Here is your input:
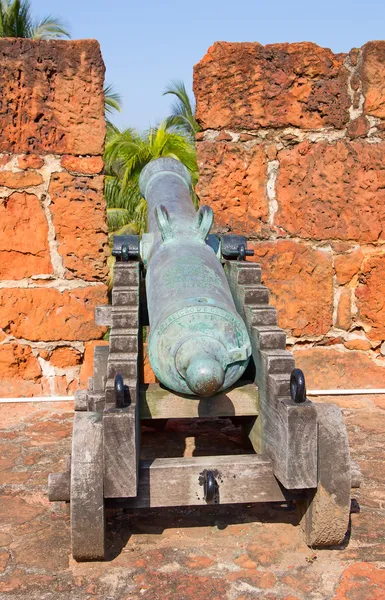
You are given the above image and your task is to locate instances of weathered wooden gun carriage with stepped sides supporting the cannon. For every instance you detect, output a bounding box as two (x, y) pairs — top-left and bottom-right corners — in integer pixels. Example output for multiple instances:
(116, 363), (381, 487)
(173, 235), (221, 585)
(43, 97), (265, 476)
(49, 159), (360, 561)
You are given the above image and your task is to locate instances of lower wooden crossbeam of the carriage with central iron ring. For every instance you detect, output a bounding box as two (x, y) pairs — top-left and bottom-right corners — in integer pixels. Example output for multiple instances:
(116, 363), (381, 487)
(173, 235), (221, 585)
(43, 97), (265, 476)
(124, 454), (292, 507)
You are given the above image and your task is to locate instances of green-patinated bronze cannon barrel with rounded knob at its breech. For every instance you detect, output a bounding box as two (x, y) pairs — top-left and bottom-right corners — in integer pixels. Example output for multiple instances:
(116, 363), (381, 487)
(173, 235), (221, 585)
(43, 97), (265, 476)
(139, 158), (251, 396)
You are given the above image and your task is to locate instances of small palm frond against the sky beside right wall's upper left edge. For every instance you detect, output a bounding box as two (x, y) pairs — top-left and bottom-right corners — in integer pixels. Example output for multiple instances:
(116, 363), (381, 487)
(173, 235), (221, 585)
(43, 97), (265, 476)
(163, 81), (200, 140)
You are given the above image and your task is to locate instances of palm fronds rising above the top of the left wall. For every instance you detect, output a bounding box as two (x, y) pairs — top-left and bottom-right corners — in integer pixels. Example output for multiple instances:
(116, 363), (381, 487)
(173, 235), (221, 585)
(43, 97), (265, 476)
(0, 0), (70, 40)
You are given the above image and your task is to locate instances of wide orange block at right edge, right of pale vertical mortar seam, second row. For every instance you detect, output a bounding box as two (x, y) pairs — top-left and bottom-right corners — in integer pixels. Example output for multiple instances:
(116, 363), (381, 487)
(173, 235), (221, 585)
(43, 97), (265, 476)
(275, 140), (385, 242)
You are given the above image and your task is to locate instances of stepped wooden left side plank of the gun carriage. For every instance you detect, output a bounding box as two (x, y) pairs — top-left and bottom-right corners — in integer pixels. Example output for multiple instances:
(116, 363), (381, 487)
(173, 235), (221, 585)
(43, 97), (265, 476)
(103, 261), (140, 498)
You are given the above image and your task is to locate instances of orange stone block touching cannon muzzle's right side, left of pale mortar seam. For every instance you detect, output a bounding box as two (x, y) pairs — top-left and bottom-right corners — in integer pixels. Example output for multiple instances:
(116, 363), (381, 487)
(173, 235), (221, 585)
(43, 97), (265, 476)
(197, 142), (268, 235)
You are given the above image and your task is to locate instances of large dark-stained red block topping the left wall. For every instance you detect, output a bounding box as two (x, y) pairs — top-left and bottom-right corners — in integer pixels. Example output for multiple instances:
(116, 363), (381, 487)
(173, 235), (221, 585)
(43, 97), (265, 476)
(0, 38), (106, 155)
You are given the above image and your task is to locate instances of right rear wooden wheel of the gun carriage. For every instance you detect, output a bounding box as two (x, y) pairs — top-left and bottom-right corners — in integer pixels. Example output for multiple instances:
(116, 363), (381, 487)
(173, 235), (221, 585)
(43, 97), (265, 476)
(297, 404), (352, 547)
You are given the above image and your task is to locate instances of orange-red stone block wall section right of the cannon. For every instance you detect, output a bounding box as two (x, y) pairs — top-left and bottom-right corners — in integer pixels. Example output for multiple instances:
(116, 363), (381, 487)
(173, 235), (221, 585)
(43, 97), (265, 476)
(194, 42), (385, 388)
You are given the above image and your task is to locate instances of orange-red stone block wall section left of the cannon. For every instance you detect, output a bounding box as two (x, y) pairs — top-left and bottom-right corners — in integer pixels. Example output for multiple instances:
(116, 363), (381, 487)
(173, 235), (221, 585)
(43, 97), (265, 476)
(0, 39), (108, 397)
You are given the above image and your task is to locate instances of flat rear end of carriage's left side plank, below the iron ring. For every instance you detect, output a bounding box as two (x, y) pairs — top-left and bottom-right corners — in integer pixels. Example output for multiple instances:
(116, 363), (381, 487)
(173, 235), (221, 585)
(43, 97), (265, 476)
(103, 404), (140, 498)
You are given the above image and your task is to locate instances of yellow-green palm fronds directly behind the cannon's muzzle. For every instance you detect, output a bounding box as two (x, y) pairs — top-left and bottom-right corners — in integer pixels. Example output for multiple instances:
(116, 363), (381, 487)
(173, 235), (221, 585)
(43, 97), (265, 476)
(104, 121), (198, 234)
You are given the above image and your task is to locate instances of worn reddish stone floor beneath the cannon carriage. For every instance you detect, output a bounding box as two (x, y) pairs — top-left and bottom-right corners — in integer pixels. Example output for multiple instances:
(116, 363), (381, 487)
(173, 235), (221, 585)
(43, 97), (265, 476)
(0, 396), (385, 600)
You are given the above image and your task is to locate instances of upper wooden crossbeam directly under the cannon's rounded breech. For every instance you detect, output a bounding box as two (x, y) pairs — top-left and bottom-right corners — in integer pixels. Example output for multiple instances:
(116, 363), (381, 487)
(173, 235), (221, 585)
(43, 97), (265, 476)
(139, 382), (258, 419)
